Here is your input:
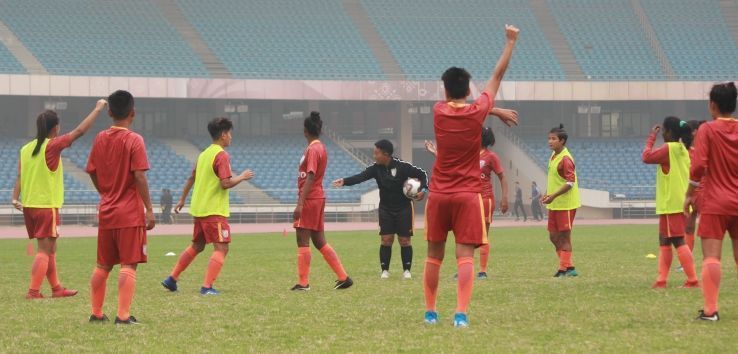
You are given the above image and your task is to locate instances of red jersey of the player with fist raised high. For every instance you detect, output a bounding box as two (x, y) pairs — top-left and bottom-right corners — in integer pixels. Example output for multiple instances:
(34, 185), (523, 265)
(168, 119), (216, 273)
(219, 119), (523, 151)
(430, 92), (493, 193)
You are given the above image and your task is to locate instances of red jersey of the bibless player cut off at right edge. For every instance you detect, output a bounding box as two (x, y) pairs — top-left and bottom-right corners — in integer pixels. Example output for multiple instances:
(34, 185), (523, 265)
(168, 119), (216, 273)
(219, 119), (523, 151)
(689, 118), (738, 216)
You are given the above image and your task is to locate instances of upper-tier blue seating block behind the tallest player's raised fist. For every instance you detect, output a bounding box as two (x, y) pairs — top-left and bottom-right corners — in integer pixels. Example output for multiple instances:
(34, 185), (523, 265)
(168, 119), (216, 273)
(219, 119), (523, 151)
(362, 0), (565, 80)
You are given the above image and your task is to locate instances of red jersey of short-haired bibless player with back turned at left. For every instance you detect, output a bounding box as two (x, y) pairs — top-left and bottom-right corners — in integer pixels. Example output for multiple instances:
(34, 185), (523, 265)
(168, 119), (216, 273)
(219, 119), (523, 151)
(86, 127), (149, 230)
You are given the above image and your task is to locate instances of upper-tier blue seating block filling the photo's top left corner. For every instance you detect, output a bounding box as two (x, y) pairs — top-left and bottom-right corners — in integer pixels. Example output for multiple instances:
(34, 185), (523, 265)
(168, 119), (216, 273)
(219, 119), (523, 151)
(0, 0), (207, 77)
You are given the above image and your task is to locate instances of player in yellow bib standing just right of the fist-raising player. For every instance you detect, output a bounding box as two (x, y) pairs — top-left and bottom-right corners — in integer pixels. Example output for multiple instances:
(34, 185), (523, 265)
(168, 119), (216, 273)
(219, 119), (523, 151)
(541, 124), (582, 277)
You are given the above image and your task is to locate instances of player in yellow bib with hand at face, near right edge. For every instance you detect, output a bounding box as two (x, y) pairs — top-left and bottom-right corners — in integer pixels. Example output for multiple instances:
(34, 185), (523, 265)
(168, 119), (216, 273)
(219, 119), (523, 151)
(642, 117), (699, 289)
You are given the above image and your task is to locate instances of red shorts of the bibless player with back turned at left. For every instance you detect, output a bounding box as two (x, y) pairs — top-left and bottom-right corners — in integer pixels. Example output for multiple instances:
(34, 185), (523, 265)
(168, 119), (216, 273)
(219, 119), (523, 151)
(97, 226), (147, 266)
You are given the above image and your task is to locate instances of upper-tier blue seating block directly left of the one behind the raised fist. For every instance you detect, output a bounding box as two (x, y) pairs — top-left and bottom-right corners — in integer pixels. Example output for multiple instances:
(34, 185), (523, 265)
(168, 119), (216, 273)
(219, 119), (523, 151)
(177, 0), (385, 80)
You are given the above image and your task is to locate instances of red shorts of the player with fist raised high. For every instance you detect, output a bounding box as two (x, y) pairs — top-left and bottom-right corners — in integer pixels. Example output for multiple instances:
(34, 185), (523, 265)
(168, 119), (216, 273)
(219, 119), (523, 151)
(425, 192), (489, 246)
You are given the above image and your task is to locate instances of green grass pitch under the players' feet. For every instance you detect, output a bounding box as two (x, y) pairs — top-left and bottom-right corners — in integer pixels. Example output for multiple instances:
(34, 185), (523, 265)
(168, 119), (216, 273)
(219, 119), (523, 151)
(0, 226), (738, 353)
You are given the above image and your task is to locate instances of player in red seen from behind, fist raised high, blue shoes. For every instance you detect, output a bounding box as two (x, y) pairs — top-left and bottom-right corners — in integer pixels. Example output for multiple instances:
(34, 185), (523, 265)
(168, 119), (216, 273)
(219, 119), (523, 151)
(423, 25), (519, 327)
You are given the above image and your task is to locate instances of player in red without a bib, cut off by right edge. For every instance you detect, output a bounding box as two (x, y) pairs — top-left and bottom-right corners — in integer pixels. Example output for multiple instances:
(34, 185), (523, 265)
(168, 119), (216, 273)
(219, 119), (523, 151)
(684, 82), (738, 321)
